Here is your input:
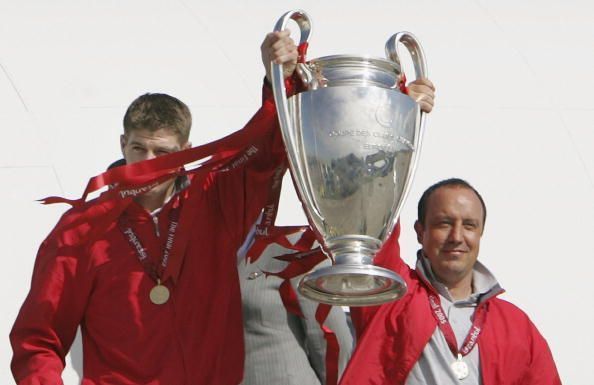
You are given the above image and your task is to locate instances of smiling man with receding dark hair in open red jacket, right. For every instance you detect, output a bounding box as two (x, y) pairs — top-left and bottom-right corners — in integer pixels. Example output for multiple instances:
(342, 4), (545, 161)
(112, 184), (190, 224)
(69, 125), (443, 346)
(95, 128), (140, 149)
(341, 179), (561, 385)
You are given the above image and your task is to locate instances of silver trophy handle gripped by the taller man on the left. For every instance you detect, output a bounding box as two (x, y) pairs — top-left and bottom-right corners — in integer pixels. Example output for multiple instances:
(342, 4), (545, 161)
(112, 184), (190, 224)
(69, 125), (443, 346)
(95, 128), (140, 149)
(270, 10), (322, 220)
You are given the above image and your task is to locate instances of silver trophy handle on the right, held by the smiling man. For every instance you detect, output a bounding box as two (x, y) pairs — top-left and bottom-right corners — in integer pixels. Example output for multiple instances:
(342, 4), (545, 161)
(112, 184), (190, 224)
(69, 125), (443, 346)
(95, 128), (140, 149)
(386, 31), (428, 239)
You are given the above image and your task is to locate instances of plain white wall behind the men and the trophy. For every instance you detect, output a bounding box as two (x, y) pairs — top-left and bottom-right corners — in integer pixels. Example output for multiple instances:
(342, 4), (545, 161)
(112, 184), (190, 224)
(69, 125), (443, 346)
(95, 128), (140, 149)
(0, 0), (594, 385)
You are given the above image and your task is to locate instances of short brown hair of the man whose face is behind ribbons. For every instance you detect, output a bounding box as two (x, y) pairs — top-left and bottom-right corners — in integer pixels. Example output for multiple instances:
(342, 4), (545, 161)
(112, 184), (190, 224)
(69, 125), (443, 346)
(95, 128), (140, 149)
(124, 94), (192, 144)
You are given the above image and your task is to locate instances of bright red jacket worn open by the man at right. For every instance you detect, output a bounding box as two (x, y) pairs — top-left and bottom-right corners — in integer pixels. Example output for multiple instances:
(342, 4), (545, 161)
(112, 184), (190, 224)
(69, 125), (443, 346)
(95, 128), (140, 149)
(340, 228), (561, 385)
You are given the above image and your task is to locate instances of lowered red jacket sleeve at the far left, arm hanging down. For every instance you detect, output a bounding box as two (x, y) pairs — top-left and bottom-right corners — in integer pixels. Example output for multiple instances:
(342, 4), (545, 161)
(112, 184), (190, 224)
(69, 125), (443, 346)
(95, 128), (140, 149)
(10, 225), (90, 385)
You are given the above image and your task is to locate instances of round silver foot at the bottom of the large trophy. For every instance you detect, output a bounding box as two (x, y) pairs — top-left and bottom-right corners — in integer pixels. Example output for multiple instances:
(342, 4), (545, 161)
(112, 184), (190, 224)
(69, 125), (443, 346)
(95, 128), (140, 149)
(299, 265), (406, 306)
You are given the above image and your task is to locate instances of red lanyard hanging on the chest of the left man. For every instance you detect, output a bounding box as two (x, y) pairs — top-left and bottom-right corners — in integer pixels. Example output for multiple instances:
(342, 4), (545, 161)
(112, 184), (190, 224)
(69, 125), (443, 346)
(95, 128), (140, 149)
(118, 197), (181, 282)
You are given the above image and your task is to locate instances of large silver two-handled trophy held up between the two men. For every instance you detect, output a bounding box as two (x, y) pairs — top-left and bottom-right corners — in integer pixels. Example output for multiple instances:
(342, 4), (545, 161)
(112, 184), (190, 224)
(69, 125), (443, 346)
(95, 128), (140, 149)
(272, 11), (427, 306)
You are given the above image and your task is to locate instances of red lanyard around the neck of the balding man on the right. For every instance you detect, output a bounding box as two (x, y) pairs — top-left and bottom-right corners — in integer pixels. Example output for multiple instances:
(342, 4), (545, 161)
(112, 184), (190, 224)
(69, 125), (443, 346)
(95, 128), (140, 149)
(429, 293), (486, 356)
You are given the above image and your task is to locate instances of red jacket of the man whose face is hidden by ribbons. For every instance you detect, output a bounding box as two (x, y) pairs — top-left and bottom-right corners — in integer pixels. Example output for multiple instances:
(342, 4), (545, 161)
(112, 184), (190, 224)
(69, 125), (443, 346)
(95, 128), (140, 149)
(10, 88), (284, 385)
